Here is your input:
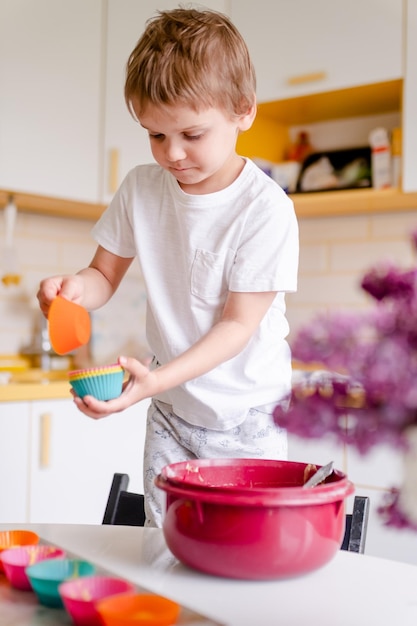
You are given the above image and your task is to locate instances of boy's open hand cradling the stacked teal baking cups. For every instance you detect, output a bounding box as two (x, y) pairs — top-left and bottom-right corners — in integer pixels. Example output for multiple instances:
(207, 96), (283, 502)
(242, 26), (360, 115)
(71, 357), (156, 419)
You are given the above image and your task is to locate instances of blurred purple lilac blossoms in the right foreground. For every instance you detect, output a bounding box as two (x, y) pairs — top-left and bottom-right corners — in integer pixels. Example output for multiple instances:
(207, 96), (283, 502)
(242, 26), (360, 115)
(274, 231), (417, 530)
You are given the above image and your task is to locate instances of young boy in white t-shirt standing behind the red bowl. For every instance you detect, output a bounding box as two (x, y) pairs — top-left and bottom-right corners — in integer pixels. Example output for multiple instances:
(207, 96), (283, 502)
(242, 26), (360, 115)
(38, 9), (298, 526)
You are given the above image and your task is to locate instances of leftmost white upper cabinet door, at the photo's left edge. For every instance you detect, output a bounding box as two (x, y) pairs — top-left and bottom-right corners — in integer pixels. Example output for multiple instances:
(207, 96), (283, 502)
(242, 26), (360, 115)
(0, 0), (103, 202)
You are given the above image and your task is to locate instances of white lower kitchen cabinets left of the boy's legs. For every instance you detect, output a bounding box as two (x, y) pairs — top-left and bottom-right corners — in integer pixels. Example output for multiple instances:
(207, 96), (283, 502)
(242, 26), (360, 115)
(0, 399), (149, 524)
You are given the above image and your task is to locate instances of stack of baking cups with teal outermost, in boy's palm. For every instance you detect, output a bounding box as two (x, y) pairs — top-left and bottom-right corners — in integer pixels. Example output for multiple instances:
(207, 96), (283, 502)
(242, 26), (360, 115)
(69, 364), (124, 401)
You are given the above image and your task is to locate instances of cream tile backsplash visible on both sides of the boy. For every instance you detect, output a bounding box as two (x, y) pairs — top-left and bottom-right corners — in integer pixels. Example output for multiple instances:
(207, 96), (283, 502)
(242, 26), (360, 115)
(0, 207), (417, 362)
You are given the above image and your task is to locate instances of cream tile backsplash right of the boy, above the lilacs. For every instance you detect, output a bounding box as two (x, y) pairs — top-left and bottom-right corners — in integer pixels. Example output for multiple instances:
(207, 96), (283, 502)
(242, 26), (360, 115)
(287, 207), (417, 342)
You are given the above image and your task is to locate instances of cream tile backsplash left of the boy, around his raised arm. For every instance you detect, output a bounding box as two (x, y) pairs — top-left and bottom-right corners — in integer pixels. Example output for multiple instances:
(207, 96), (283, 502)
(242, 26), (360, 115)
(0, 212), (147, 363)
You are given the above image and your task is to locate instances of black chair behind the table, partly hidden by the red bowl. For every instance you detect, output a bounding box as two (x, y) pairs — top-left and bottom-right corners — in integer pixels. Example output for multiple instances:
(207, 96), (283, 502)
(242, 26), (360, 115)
(103, 474), (369, 553)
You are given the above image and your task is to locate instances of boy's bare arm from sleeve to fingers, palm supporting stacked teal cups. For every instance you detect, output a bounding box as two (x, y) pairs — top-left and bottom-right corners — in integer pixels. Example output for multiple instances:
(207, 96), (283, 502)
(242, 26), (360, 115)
(75, 292), (276, 418)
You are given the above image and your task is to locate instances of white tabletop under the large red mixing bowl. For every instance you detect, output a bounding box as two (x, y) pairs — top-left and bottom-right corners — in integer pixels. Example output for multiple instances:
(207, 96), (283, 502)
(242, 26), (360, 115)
(0, 524), (417, 626)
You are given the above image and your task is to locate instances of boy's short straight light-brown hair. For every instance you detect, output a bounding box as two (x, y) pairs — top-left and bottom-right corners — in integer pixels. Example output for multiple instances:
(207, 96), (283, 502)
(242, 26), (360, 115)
(125, 8), (256, 117)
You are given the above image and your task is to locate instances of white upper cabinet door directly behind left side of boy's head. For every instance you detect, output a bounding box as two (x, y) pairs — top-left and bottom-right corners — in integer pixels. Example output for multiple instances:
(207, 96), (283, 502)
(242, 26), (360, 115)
(102, 0), (226, 202)
